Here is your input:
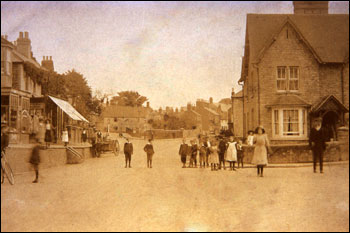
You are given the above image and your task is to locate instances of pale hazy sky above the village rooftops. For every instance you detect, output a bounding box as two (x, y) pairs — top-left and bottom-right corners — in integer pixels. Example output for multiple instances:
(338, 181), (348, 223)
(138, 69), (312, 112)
(1, 1), (349, 108)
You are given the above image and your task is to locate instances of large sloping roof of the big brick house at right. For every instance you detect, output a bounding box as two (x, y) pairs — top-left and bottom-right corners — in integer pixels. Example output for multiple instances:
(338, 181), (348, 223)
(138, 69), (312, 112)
(245, 14), (349, 63)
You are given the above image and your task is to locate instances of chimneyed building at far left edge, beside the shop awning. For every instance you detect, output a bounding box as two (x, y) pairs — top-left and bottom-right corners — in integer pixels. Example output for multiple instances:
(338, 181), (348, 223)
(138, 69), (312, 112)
(1, 32), (42, 143)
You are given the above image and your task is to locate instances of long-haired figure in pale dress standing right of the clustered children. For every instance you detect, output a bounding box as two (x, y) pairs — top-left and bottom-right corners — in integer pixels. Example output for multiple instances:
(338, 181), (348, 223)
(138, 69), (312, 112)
(252, 126), (270, 177)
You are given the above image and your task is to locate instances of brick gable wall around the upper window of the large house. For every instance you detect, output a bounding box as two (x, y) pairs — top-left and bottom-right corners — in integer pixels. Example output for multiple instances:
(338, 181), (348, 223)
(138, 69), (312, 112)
(254, 24), (324, 141)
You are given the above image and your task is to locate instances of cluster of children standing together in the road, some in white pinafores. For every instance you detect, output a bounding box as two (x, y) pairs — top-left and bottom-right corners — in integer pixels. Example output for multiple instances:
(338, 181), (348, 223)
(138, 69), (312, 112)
(179, 137), (244, 171)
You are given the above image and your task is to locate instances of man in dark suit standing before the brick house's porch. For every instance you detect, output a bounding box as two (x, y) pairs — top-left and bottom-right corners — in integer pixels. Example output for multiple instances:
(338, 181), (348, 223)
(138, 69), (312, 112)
(309, 119), (326, 173)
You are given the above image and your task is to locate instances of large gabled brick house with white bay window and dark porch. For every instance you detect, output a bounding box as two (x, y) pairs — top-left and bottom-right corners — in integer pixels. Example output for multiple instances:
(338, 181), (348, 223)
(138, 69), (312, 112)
(239, 2), (349, 143)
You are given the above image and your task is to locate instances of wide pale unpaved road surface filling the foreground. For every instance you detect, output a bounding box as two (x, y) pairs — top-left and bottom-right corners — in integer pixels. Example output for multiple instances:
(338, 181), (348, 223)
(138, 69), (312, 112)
(1, 140), (349, 232)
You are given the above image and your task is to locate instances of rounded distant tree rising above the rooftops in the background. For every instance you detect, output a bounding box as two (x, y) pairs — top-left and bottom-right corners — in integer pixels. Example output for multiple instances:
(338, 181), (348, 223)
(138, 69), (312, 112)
(111, 91), (148, 107)
